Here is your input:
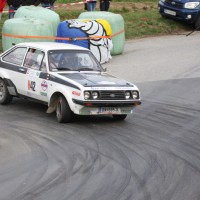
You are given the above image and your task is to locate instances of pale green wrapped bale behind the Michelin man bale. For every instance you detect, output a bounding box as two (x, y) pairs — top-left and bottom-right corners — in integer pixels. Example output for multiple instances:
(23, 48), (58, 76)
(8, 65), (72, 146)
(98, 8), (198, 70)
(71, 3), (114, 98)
(78, 11), (125, 55)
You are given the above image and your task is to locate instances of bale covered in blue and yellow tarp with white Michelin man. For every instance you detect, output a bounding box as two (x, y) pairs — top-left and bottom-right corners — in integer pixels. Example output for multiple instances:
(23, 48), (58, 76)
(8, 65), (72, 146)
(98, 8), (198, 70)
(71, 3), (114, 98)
(57, 19), (113, 63)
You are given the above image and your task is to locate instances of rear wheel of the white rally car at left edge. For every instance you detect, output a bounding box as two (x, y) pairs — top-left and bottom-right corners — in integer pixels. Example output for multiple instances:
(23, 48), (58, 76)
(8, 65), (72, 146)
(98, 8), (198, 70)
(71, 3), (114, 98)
(0, 79), (13, 105)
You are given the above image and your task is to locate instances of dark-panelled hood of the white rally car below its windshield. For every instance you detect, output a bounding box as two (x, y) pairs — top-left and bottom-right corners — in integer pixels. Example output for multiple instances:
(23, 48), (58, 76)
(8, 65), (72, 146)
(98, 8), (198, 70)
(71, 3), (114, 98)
(59, 72), (133, 87)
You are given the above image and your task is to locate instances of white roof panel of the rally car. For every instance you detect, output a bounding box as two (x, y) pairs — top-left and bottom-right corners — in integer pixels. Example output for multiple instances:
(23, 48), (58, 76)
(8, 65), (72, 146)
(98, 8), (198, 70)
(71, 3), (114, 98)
(16, 42), (88, 51)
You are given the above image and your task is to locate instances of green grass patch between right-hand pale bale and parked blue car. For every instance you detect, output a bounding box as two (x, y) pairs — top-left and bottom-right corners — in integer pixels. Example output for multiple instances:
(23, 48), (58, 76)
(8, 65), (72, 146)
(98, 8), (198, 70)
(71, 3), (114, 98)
(119, 9), (191, 39)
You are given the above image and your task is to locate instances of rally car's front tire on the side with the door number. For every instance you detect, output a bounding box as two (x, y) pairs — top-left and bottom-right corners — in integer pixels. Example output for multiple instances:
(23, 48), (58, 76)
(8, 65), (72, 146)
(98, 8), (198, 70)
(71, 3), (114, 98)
(56, 96), (73, 123)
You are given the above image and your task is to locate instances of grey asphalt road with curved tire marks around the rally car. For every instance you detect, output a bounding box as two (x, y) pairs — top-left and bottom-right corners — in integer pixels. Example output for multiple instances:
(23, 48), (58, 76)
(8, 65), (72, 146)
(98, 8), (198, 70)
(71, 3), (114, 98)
(0, 33), (200, 200)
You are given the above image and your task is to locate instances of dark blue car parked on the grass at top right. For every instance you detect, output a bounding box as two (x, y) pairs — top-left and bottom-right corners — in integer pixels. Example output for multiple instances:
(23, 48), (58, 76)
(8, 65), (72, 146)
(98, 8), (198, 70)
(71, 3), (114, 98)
(158, 0), (200, 29)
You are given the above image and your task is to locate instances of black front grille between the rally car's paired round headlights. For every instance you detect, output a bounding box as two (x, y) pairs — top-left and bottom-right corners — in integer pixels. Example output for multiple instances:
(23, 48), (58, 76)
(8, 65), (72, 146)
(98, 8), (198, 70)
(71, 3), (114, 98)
(100, 90), (125, 100)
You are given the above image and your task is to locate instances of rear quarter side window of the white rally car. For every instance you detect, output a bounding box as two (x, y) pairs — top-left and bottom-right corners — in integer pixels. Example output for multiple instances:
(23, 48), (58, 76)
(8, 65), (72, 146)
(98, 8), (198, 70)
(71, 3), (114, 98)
(3, 47), (26, 65)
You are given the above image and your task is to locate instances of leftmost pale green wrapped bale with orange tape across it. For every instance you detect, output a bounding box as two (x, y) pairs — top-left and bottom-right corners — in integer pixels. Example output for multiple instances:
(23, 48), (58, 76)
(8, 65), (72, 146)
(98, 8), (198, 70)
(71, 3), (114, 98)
(2, 18), (54, 51)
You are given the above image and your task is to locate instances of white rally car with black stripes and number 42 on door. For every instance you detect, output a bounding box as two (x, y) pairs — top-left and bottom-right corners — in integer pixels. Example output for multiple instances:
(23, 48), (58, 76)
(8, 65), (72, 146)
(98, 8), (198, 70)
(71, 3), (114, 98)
(0, 42), (141, 122)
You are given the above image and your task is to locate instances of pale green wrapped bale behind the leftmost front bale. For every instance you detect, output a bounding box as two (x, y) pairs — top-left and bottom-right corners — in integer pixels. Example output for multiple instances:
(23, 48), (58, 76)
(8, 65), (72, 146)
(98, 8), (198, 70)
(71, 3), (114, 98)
(14, 6), (60, 36)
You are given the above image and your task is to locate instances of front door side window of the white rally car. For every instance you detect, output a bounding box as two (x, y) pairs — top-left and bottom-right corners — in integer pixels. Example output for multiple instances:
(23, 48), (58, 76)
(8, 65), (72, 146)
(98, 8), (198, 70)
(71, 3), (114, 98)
(24, 48), (44, 70)
